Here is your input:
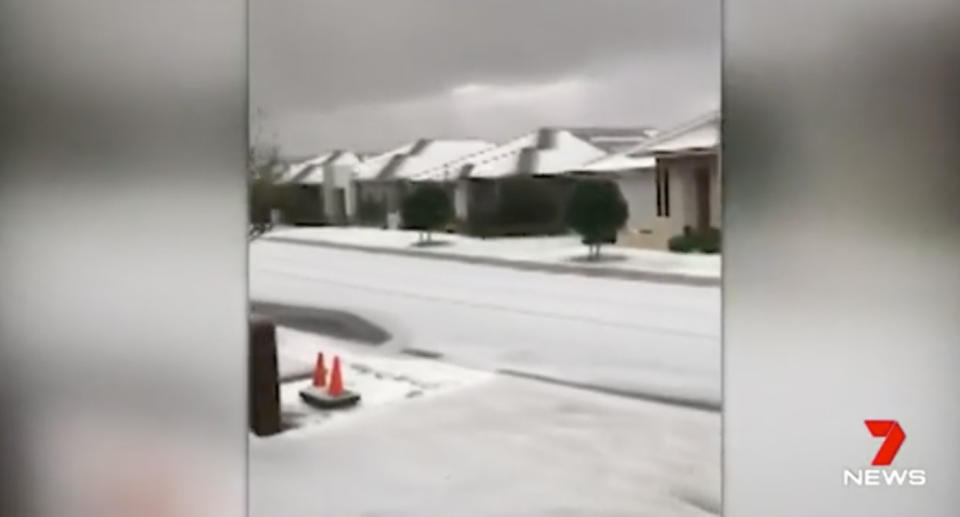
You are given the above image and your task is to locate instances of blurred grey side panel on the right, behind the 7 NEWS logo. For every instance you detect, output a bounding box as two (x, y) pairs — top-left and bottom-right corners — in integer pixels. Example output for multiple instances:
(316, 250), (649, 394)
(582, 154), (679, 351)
(723, 0), (960, 517)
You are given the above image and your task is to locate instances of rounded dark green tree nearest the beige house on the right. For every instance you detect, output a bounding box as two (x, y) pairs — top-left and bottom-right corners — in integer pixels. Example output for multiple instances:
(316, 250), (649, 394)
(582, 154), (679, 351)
(567, 179), (629, 260)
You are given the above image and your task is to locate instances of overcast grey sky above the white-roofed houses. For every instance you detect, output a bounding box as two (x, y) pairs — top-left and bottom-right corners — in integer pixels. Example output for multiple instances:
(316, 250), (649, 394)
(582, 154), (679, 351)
(250, 0), (721, 155)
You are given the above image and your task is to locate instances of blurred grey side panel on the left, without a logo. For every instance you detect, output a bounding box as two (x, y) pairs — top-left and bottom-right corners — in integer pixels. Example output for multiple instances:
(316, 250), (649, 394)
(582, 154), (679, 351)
(0, 0), (248, 515)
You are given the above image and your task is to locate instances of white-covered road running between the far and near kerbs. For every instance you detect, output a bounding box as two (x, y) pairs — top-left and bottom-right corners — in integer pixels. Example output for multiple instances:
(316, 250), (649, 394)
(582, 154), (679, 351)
(250, 241), (720, 405)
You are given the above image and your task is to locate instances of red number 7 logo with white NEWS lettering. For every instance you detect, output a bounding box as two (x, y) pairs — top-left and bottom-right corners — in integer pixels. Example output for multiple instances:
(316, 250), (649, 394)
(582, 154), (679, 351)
(843, 420), (927, 486)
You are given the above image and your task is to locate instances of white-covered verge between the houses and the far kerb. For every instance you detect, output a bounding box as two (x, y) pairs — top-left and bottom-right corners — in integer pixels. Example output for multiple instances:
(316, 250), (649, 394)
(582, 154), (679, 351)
(266, 227), (720, 278)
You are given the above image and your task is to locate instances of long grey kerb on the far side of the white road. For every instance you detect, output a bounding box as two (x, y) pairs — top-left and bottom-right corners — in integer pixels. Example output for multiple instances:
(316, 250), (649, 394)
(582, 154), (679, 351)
(260, 236), (720, 287)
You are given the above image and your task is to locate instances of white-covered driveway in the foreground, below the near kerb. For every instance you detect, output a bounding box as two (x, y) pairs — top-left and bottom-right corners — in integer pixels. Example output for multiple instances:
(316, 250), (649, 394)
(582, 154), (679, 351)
(249, 377), (720, 517)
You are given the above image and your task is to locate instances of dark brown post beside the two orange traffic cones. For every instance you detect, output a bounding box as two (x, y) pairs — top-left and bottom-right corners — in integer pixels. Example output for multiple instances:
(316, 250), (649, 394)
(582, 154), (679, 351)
(248, 315), (281, 436)
